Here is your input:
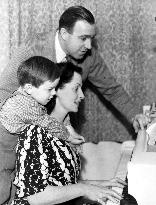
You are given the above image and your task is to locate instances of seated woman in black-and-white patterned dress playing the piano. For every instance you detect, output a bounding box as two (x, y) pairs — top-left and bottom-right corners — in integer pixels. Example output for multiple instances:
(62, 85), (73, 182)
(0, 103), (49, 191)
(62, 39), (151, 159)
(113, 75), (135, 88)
(11, 63), (124, 205)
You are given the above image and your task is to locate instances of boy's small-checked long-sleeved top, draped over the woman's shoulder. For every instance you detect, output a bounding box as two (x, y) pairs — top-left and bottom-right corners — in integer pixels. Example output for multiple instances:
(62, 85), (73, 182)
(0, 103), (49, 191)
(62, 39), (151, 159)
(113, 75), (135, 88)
(0, 88), (69, 140)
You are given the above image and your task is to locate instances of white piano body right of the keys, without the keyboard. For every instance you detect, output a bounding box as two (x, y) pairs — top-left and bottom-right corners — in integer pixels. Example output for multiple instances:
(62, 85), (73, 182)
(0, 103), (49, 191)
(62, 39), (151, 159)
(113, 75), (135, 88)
(127, 123), (156, 205)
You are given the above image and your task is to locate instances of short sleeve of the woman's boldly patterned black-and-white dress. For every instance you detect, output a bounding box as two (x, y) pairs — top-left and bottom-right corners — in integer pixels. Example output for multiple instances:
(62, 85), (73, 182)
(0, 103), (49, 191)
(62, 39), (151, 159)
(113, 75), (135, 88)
(14, 125), (48, 197)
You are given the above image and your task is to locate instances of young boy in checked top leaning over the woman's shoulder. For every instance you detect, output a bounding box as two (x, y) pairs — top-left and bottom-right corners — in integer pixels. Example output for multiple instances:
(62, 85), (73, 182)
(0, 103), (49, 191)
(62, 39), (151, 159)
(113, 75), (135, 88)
(0, 56), (84, 144)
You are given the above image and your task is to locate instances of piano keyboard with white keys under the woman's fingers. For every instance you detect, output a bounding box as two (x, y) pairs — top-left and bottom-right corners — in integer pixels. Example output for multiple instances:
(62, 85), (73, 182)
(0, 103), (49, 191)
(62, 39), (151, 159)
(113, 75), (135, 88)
(106, 141), (135, 205)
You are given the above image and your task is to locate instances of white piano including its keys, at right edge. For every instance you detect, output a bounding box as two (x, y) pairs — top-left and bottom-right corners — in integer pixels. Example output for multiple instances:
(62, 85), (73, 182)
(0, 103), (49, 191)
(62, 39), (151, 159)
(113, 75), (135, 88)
(106, 122), (156, 205)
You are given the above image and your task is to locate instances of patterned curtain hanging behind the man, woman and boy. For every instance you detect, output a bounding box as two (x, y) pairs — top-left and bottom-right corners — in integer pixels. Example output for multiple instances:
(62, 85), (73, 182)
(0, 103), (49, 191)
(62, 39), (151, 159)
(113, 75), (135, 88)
(0, 0), (156, 142)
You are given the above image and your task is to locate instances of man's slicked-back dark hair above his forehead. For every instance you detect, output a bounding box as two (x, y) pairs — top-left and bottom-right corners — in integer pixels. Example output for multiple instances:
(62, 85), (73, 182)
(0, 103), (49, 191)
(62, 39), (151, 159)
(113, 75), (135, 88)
(59, 6), (95, 33)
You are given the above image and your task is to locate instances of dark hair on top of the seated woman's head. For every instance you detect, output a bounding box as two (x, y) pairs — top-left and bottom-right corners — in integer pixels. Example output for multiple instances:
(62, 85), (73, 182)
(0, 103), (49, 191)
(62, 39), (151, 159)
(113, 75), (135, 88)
(56, 62), (82, 90)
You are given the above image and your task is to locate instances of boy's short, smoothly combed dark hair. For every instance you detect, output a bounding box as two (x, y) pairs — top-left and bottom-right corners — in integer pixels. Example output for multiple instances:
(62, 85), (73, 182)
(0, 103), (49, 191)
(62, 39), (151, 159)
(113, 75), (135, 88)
(17, 56), (62, 88)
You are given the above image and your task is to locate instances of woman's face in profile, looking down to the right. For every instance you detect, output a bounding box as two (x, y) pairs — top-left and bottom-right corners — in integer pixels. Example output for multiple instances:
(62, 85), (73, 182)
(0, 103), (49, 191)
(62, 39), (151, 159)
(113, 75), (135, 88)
(56, 72), (84, 113)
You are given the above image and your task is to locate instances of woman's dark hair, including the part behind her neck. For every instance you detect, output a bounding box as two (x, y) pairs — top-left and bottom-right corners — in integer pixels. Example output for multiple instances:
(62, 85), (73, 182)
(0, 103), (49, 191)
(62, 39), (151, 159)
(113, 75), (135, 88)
(46, 62), (82, 114)
